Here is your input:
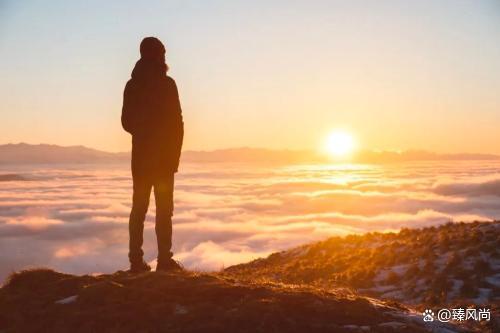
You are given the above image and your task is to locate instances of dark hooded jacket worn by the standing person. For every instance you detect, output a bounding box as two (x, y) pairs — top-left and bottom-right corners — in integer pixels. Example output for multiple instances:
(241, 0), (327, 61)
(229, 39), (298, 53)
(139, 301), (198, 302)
(121, 59), (184, 177)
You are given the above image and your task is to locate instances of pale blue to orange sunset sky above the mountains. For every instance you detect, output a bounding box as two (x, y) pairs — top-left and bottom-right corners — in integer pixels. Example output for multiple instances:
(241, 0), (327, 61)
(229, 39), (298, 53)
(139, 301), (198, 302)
(0, 0), (500, 154)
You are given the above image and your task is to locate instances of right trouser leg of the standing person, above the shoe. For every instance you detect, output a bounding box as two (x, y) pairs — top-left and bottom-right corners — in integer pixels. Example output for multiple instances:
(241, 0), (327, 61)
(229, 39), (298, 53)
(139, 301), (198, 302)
(154, 173), (174, 264)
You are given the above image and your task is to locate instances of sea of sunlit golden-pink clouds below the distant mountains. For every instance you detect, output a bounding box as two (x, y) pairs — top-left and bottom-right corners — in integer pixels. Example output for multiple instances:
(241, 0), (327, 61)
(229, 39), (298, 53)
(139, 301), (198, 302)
(0, 161), (500, 281)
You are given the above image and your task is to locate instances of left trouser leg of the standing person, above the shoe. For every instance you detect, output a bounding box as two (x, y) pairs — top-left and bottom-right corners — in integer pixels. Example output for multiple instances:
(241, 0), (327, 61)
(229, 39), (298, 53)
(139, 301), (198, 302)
(128, 176), (153, 264)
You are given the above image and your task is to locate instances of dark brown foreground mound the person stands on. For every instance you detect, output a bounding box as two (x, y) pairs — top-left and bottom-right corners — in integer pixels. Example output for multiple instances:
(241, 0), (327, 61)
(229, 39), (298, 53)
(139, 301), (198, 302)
(0, 269), (458, 333)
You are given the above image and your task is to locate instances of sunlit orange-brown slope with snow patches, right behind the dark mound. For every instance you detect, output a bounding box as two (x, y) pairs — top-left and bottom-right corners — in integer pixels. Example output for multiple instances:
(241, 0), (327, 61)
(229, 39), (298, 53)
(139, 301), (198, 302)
(223, 221), (500, 332)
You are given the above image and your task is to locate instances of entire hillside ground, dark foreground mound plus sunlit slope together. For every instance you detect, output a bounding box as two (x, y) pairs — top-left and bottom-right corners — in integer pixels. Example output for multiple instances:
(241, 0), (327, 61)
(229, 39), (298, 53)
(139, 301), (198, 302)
(0, 222), (500, 333)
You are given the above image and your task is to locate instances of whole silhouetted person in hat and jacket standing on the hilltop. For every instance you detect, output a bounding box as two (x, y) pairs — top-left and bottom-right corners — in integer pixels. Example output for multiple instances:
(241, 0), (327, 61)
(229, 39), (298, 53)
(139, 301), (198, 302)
(122, 37), (184, 272)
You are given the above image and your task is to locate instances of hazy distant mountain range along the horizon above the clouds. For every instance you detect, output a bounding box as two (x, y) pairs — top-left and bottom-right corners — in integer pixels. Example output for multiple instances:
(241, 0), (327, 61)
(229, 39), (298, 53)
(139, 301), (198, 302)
(0, 143), (500, 164)
